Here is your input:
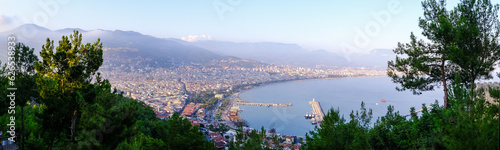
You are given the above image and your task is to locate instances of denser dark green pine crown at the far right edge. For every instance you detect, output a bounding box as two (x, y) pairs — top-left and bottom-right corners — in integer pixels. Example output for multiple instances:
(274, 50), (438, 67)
(450, 0), (500, 91)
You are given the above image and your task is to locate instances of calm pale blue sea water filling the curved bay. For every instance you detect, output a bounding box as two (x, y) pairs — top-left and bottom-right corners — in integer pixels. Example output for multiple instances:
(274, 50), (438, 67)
(240, 77), (498, 136)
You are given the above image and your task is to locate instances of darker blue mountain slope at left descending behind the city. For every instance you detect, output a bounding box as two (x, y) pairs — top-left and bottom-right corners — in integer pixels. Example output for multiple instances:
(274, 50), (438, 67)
(0, 24), (223, 67)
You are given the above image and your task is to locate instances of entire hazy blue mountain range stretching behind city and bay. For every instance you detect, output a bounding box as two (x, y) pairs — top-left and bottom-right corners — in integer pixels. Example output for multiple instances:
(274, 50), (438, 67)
(0, 24), (395, 69)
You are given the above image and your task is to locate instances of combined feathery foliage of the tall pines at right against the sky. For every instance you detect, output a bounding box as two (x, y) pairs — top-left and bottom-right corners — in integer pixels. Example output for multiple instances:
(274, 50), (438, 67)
(387, 0), (500, 108)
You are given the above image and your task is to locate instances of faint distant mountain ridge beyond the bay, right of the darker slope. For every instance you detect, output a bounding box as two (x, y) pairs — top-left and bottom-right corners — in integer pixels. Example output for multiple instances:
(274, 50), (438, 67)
(178, 41), (395, 69)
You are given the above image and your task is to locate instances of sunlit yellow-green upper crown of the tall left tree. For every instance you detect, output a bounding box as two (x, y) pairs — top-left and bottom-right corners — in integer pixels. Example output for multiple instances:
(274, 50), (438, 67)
(35, 30), (103, 96)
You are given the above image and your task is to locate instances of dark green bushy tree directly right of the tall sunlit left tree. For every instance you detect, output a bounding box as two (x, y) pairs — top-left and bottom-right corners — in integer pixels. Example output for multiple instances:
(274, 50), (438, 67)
(71, 76), (141, 149)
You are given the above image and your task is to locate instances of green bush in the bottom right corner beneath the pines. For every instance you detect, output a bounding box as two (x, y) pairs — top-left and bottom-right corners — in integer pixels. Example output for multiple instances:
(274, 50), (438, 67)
(433, 78), (499, 149)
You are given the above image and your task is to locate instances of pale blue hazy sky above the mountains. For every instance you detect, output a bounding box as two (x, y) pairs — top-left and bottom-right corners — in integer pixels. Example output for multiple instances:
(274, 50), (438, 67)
(0, 0), (472, 52)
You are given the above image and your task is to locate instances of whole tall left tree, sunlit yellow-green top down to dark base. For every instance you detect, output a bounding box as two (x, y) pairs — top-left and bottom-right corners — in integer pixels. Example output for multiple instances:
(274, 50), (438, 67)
(35, 31), (103, 148)
